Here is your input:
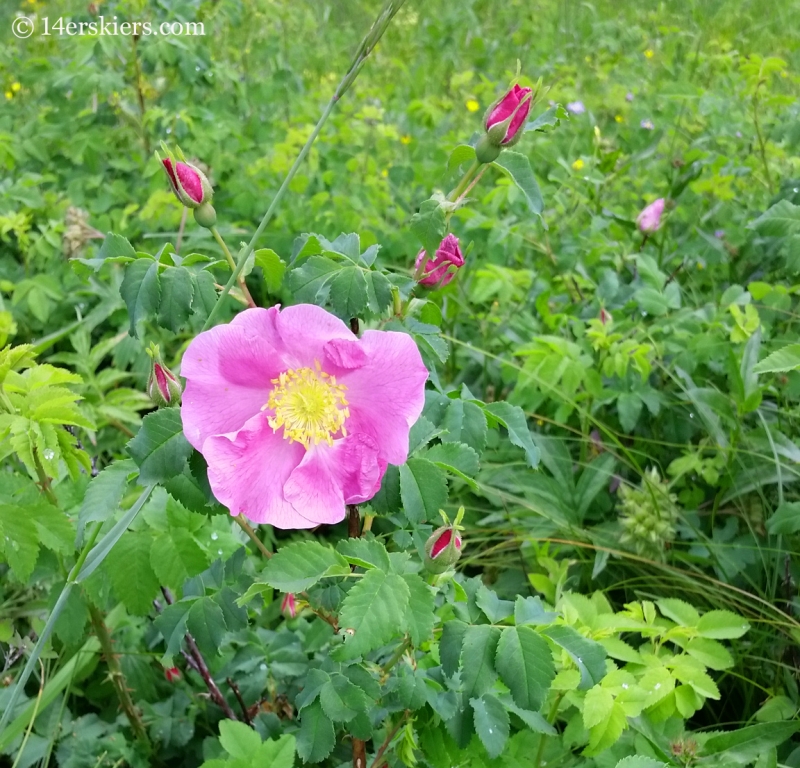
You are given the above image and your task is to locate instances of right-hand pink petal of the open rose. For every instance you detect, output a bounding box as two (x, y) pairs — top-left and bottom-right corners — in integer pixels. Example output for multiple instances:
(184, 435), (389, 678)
(337, 331), (428, 464)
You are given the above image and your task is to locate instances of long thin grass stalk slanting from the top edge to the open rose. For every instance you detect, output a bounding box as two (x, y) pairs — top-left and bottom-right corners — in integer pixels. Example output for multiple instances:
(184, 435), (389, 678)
(203, 0), (405, 331)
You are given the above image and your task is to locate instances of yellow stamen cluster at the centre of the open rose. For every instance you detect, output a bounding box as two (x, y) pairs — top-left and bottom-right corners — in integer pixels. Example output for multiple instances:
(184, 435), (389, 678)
(264, 363), (350, 448)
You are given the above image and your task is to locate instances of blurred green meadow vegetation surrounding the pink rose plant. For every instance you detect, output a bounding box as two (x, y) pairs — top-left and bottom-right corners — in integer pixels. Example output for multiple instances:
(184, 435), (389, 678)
(0, 0), (800, 768)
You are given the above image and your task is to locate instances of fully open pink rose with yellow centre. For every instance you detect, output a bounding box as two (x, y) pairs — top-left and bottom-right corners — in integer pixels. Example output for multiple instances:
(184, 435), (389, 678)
(181, 304), (428, 528)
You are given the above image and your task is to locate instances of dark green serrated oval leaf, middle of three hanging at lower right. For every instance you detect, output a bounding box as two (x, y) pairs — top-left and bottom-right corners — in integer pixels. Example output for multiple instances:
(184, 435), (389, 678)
(495, 626), (556, 712)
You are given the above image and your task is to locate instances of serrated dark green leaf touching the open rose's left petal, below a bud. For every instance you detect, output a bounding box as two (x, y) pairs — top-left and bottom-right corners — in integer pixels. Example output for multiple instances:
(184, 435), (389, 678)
(127, 408), (192, 485)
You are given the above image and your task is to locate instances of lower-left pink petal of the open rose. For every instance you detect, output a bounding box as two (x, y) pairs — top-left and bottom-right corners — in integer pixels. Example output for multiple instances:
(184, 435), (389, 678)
(202, 413), (310, 528)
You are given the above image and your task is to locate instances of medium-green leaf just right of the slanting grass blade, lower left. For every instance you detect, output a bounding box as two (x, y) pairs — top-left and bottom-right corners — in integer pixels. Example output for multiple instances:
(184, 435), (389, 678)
(104, 531), (159, 616)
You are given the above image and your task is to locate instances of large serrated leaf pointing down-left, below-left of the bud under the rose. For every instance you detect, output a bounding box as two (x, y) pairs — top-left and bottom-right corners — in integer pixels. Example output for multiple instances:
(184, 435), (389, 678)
(332, 558), (410, 661)
